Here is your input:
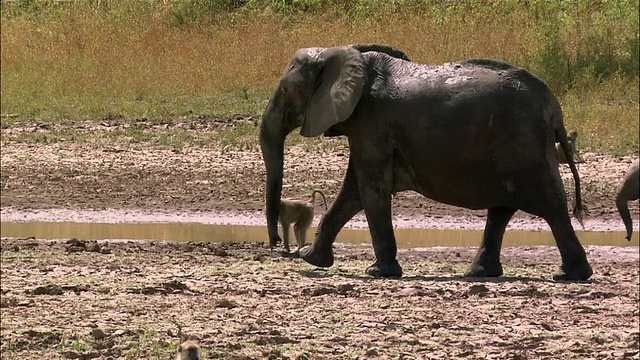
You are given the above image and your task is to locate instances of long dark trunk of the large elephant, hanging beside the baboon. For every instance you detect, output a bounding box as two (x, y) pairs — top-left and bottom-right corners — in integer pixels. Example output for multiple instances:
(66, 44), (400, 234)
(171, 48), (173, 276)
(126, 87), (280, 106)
(260, 98), (287, 246)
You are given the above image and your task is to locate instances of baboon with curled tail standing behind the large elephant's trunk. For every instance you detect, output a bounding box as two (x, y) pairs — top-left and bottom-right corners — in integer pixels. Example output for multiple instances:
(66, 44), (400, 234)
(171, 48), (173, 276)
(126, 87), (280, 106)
(278, 190), (328, 254)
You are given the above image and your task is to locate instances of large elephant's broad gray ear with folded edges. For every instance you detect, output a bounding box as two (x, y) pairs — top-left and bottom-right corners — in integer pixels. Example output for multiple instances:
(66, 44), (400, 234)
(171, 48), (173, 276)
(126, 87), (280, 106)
(300, 46), (364, 137)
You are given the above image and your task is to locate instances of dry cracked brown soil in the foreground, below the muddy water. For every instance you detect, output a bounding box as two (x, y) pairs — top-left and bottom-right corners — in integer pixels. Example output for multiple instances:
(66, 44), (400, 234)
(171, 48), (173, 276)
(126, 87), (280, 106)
(0, 239), (640, 359)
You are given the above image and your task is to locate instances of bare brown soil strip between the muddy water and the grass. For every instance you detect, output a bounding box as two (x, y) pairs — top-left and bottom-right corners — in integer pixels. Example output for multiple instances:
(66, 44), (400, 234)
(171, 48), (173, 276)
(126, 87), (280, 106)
(0, 117), (639, 230)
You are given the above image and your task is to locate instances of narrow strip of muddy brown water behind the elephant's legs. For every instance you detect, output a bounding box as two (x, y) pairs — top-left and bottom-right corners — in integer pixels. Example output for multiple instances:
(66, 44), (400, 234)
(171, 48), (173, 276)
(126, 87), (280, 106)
(0, 222), (638, 248)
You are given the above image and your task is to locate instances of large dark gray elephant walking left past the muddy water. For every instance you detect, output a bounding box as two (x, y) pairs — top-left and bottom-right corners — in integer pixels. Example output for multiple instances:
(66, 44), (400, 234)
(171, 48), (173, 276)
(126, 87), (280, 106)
(260, 45), (593, 280)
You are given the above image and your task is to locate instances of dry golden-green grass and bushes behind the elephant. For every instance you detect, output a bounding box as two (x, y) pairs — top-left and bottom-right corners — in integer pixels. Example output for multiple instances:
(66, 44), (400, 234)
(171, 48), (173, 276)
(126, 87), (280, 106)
(0, 0), (639, 153)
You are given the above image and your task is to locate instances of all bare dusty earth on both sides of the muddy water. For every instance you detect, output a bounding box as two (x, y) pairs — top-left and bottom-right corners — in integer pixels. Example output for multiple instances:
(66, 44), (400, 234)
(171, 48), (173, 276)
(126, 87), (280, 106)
(0, 117), (640, 359)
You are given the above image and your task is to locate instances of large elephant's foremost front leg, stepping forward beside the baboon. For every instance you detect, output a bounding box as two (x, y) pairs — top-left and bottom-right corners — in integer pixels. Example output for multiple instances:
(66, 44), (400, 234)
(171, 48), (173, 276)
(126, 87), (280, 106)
(299, 158), (362, 267)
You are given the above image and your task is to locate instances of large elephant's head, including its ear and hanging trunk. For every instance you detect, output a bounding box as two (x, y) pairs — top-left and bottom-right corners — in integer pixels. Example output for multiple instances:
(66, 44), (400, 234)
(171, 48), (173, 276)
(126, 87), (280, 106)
(260, 46), (365, 245)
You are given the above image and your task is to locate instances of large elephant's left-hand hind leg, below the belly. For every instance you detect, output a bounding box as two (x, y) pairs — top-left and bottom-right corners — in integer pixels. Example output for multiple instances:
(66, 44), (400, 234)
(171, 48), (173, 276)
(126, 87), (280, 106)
(464, 207), (517, 277)
